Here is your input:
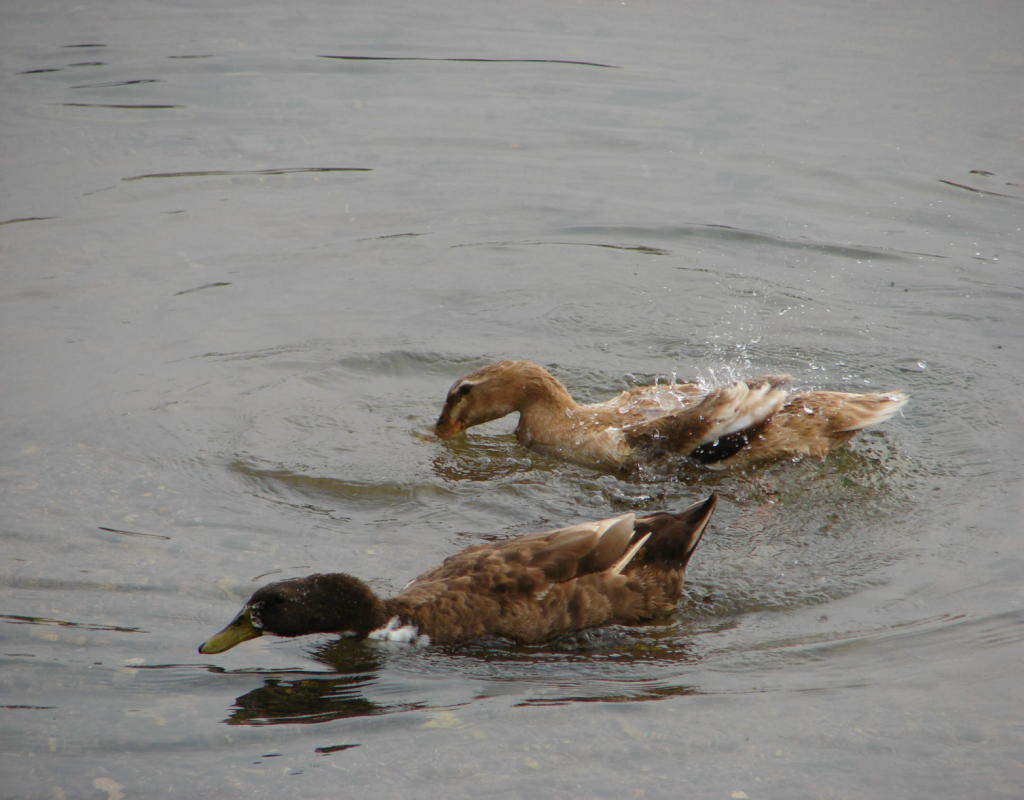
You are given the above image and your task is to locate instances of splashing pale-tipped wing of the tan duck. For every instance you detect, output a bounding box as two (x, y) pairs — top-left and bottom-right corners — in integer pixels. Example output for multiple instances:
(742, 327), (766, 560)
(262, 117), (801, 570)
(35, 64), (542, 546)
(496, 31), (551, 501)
(623, 375), (790, 455)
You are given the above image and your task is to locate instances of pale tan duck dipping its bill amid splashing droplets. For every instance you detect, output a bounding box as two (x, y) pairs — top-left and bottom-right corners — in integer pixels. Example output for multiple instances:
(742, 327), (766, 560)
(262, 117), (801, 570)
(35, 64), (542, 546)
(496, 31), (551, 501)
(435, 361), (907, 470)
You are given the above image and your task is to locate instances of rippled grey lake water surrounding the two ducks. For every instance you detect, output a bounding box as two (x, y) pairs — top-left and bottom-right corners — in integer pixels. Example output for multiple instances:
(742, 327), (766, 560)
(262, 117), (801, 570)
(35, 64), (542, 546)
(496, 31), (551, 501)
(0, 0), (1024, 800)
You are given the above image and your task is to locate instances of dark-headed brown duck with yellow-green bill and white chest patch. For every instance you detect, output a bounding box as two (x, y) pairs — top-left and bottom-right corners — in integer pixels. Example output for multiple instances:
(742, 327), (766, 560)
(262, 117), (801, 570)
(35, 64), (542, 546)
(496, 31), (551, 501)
(199, 495), (717, 655)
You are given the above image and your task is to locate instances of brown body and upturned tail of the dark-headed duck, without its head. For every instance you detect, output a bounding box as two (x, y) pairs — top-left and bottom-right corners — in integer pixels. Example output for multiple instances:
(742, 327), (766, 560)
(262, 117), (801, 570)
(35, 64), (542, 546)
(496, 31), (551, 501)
(395, 496), (715, 644)
